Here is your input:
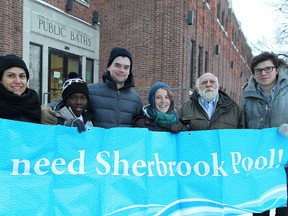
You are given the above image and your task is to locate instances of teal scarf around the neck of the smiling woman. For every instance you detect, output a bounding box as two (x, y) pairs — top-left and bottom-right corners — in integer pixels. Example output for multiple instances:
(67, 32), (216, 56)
(147, 106), (178, 129)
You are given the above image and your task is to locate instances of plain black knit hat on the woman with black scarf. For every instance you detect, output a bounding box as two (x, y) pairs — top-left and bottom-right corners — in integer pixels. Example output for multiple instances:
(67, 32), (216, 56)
(0, 54), (29, 80)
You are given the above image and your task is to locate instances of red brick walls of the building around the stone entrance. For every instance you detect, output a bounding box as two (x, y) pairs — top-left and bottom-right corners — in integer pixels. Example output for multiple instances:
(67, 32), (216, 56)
(0, 0), (252, 107)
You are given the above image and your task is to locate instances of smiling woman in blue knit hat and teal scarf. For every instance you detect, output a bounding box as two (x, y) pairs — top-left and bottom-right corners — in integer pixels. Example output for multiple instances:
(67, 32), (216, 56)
(132, 82), (186, 133)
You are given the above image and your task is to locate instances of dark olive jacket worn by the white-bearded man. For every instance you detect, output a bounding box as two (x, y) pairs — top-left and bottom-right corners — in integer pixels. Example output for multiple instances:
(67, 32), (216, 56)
(180, 90), (244, 130)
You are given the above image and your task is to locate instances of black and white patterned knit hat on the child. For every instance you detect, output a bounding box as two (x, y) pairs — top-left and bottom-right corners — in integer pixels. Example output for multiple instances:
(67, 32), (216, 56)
(62, 74), (89, 104)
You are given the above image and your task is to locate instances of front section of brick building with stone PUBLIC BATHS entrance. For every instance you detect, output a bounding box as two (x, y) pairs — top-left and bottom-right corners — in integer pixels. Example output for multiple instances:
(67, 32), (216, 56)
(0, 0), (100, 103)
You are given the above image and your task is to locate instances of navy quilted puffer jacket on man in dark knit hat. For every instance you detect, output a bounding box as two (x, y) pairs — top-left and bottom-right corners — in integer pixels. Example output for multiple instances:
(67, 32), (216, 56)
(88, 72), (143, 128)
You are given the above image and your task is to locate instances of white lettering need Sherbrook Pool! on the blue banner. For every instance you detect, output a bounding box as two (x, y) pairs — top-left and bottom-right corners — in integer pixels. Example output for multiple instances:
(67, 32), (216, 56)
(10, 149), (284, 177)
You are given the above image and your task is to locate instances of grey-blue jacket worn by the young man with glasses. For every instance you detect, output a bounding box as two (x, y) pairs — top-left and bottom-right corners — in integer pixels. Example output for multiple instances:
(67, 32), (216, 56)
(241, 67), (288, 129)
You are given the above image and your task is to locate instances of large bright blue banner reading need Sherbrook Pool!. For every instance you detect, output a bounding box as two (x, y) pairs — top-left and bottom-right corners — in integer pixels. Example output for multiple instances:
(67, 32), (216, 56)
(0, 119), (288, 216)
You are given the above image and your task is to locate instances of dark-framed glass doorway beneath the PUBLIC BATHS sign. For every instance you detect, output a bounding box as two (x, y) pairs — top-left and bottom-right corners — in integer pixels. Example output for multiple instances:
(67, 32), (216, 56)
(48, 49), (82, 103)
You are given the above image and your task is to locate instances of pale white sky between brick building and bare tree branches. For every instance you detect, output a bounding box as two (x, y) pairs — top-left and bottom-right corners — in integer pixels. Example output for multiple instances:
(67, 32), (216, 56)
(232, 0), (280, 52)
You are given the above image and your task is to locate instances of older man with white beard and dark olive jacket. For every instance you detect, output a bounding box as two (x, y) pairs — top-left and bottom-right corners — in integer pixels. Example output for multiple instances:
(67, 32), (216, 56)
(180, 73), (245, 130)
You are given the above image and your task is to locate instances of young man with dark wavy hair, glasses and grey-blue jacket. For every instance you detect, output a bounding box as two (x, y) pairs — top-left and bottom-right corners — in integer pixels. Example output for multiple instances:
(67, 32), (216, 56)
(241, 52), (288, 216)
